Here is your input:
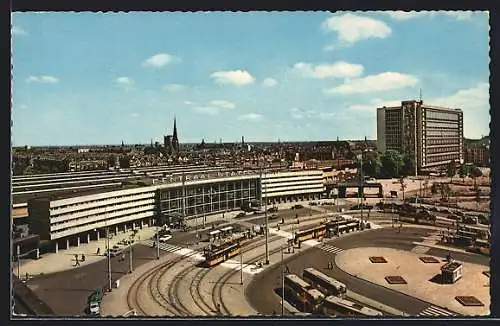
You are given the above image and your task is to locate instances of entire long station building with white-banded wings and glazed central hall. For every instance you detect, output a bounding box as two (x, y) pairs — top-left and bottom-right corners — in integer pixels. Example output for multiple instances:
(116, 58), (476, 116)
(28, 170), (325, 251)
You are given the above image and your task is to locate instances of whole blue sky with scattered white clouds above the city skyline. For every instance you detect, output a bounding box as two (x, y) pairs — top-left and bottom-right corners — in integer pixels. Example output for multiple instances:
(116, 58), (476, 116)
(12, 12), (490, 146)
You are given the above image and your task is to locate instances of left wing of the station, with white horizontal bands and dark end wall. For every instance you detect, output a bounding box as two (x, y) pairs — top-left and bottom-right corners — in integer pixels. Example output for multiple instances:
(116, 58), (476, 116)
(28, 187), (156, 251)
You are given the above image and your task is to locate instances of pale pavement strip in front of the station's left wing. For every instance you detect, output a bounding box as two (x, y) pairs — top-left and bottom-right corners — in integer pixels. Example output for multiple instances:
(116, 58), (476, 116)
(13, 227), (156, 278)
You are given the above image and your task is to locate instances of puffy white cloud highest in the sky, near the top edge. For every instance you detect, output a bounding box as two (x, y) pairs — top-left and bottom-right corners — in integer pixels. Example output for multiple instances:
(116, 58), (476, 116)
(322, 13), (392, 44)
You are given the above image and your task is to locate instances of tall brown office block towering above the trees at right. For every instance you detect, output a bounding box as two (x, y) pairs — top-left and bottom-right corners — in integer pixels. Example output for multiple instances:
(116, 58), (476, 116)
(377, 101), (464, 174)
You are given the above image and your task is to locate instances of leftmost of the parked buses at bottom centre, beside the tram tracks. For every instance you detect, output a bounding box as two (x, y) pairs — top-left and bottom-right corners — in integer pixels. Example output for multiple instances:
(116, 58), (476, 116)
(285, 274), (325, 312)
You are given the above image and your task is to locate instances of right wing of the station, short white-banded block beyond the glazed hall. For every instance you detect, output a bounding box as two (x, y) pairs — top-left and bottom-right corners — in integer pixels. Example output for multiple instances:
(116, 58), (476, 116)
(262, 170), (325, 203)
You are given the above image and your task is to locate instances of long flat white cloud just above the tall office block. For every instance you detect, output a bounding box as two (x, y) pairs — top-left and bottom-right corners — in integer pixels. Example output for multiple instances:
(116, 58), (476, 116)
(326, 72), (419, 94)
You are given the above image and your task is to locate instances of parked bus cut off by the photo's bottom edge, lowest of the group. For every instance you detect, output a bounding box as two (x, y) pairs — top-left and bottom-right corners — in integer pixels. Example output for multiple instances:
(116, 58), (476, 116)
(321, 296), (383, 317)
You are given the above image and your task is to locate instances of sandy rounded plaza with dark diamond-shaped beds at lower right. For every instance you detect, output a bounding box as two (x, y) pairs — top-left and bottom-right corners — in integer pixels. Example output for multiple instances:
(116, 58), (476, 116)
(335, 247), (490, 316)
